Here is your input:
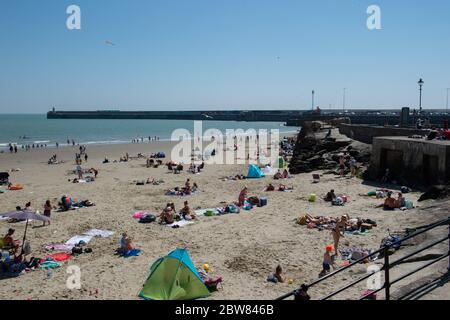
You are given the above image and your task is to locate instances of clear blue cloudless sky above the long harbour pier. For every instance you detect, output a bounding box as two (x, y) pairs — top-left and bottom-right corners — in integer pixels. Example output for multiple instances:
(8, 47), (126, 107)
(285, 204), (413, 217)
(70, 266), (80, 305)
(0, 0), (450, 113)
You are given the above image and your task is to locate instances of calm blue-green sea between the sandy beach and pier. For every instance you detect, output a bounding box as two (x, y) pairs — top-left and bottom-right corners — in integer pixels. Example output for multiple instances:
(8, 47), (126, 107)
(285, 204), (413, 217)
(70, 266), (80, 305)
(0, 114), (298, 148)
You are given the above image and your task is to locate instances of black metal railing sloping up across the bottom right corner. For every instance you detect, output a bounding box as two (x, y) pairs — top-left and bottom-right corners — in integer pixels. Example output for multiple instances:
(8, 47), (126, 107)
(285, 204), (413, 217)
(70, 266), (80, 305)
(276, 217), (450, 300)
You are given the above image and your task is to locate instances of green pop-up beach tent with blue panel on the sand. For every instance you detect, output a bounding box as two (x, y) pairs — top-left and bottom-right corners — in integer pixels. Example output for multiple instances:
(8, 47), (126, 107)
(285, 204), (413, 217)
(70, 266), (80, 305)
(139, 249), (209, 300)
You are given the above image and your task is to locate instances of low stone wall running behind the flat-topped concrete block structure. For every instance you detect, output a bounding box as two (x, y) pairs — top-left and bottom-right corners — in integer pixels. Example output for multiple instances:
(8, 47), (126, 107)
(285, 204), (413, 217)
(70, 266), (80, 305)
(339, 124), (430, 144)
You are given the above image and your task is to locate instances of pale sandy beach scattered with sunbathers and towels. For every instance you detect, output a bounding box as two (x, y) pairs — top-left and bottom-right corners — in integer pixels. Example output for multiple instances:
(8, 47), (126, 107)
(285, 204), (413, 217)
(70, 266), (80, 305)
(0, 138), (448, 300)
